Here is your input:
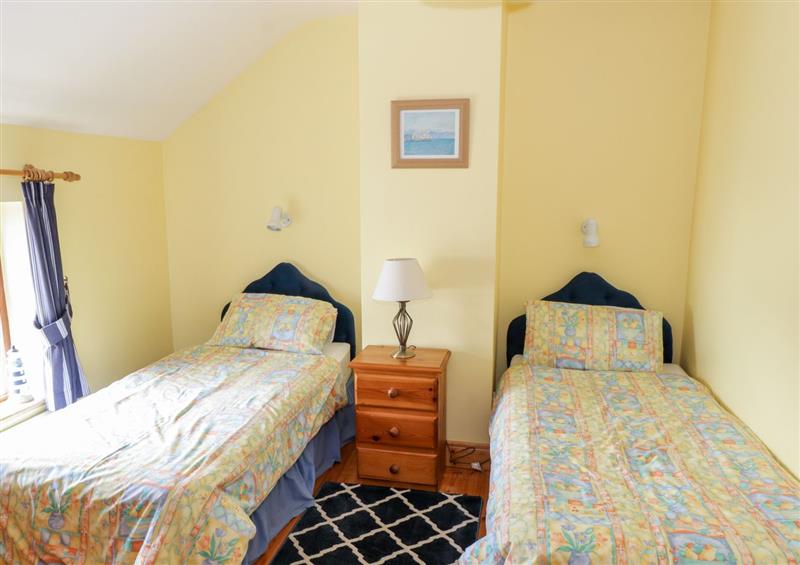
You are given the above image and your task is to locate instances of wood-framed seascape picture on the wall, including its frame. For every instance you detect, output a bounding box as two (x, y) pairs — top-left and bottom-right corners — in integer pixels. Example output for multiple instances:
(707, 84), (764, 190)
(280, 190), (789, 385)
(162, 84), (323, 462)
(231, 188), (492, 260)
(392, 98), (469, 169)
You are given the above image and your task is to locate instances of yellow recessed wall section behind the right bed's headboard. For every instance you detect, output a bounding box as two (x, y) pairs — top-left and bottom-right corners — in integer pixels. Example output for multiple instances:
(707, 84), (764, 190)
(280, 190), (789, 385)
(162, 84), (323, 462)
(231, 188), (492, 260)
(497, 2), (708, 371)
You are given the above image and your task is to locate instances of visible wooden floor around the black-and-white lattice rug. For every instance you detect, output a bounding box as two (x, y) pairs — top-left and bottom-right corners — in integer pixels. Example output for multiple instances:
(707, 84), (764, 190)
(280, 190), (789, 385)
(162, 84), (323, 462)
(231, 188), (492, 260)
(256, 443), (489, 565)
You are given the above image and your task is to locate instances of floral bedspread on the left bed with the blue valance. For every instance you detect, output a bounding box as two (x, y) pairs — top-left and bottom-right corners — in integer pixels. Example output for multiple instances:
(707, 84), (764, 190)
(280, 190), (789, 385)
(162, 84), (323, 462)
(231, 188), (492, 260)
(0, 345), (347, 565)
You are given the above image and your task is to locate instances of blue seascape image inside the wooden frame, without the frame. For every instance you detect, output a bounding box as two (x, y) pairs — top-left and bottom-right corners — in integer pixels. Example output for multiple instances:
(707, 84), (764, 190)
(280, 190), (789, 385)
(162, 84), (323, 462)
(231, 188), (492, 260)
(400, 109), (459, 159)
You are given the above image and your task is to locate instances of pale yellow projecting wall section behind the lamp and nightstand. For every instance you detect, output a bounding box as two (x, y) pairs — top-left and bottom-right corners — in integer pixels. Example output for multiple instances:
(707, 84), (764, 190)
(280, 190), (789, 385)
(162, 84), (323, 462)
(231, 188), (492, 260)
(358, 2), (502, 442)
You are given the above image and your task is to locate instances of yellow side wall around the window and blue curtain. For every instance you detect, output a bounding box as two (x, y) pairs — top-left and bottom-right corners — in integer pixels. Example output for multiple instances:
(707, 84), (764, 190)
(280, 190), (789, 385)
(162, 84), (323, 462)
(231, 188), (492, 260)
(0, 125), (172, 391)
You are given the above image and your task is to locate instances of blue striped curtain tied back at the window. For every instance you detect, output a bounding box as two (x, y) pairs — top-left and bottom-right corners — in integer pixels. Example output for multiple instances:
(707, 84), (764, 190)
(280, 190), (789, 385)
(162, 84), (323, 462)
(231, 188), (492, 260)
(22, 181), (89, 410)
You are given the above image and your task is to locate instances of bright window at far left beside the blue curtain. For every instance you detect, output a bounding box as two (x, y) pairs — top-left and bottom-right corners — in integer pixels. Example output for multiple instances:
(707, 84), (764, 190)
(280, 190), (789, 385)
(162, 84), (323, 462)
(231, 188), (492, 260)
(0, 202), (44, 400)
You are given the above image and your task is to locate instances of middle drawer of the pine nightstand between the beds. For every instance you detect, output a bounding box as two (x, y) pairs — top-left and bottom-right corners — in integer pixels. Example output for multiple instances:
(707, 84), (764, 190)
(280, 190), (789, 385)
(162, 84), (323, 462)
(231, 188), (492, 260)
(356, 408), (437, 449)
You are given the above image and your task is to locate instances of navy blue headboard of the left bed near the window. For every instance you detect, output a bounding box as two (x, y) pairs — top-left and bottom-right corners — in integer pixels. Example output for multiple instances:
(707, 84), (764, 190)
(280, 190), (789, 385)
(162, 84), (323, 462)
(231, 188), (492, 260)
(222, 263), (356, 359)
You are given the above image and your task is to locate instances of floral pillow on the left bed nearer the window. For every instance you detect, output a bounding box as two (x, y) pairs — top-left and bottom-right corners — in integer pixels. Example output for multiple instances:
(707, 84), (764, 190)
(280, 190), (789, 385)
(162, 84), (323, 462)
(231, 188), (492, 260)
(209, 293), (336, 355)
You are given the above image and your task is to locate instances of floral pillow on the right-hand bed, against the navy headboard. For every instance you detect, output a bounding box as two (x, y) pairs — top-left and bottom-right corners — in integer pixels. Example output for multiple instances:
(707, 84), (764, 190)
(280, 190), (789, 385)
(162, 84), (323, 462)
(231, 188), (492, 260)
(525, 300), (664, 371)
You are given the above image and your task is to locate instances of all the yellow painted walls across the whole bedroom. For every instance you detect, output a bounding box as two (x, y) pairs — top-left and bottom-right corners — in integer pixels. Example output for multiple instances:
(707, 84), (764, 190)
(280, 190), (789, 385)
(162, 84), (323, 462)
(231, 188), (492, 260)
(0, 1), (800, 473)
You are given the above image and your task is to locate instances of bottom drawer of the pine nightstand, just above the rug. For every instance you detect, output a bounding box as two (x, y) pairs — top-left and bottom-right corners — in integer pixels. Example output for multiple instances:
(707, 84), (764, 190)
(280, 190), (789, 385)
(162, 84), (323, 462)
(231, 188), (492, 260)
(357, 447), (436, 485)
